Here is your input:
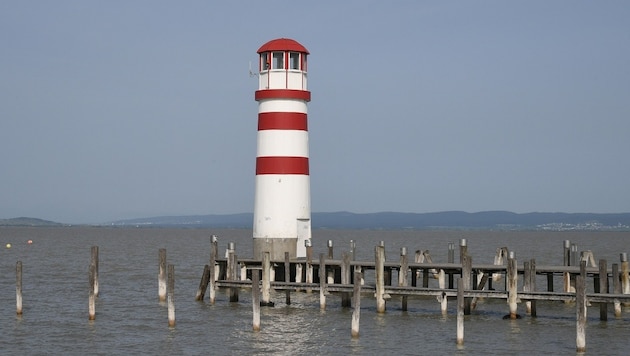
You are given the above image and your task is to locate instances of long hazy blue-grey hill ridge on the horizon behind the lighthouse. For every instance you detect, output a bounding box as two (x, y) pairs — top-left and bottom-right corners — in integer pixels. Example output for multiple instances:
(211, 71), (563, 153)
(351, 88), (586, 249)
(107, 211), (630, 231)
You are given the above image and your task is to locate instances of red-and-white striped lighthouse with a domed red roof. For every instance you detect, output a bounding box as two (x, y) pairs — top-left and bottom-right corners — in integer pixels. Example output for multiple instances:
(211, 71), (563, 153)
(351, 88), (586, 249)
(253, 38), (311, 261)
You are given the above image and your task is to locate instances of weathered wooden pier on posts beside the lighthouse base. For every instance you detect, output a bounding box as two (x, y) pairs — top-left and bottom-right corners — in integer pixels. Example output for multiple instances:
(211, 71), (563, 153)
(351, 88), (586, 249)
(197, 238), (630, 351)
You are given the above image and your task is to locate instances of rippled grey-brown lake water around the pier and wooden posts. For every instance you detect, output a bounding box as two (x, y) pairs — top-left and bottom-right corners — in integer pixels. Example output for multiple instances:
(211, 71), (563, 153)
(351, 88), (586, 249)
(0, 227), (630, 355)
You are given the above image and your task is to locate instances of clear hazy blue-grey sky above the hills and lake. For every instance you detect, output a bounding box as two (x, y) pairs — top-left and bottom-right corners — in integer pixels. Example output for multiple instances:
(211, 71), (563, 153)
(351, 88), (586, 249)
(0, 0), (630, 223)
